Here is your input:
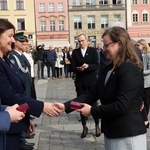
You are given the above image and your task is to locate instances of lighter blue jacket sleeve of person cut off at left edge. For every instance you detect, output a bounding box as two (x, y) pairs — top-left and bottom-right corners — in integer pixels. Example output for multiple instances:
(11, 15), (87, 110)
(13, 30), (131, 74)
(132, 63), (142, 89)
(0, 100), (11, 150)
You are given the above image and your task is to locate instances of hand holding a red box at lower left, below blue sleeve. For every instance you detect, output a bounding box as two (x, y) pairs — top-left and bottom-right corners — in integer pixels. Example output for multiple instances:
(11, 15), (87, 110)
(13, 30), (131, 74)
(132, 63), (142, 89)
(5, 104), (25, 122)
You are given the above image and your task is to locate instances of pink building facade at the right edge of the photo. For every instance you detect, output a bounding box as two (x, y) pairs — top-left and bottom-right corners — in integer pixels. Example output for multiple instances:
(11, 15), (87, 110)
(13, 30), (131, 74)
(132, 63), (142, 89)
(127, 0), (150, 44)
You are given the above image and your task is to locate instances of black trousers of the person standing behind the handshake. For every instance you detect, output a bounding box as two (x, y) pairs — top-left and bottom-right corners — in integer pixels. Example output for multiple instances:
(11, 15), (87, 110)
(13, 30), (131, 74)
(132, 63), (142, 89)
(76, 86), (99, 126)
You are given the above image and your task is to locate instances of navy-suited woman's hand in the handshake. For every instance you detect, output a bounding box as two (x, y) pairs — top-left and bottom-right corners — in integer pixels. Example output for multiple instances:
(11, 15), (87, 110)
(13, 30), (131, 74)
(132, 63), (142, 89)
(43, 102), (61, 117)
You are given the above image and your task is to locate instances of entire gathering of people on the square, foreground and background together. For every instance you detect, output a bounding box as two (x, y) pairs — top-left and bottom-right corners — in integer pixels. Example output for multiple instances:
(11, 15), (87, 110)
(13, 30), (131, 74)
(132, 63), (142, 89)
(0, 19), (150, 150)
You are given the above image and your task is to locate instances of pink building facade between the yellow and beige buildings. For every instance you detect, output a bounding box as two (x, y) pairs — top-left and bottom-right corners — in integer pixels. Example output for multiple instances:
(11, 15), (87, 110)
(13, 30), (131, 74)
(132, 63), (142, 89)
(35, 0), (70, 48)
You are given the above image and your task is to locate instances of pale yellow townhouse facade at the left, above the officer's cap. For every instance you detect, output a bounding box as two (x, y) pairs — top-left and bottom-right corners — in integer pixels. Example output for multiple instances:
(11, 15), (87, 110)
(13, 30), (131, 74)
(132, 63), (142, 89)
(0, 0), (36, 45)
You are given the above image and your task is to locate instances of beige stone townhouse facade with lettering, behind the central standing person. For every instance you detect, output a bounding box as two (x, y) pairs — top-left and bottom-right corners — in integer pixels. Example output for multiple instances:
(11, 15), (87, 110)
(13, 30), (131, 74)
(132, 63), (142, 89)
(68, 0), (126, 47)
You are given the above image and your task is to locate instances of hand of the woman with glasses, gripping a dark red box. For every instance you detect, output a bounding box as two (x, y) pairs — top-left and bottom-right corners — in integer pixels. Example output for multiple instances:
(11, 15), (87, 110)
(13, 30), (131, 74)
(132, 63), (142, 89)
(76, 104), (91, 117)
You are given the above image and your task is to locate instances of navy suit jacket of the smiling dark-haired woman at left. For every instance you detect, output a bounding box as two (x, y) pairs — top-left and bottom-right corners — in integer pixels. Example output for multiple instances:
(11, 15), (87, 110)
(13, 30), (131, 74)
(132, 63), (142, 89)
(0, 56), (43, 133)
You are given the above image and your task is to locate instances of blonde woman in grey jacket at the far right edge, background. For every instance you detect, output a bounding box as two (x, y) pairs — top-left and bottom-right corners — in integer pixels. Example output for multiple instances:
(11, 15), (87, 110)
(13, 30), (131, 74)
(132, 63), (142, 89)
(138, 39), (150, 128)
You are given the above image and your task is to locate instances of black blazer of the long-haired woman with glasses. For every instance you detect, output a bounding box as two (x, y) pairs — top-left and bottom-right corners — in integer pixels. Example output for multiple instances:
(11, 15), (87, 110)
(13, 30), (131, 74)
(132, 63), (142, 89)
(65, 62), (146, 138)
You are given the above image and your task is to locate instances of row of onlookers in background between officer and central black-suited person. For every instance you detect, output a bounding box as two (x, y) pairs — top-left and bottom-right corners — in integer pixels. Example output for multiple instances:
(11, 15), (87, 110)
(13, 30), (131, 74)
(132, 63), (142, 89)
(35, 44), (73, 79)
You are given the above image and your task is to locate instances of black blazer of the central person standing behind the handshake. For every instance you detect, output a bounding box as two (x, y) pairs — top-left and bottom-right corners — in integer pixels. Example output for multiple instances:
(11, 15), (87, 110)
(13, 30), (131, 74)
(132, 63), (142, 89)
(72, 47), (98, 87)
